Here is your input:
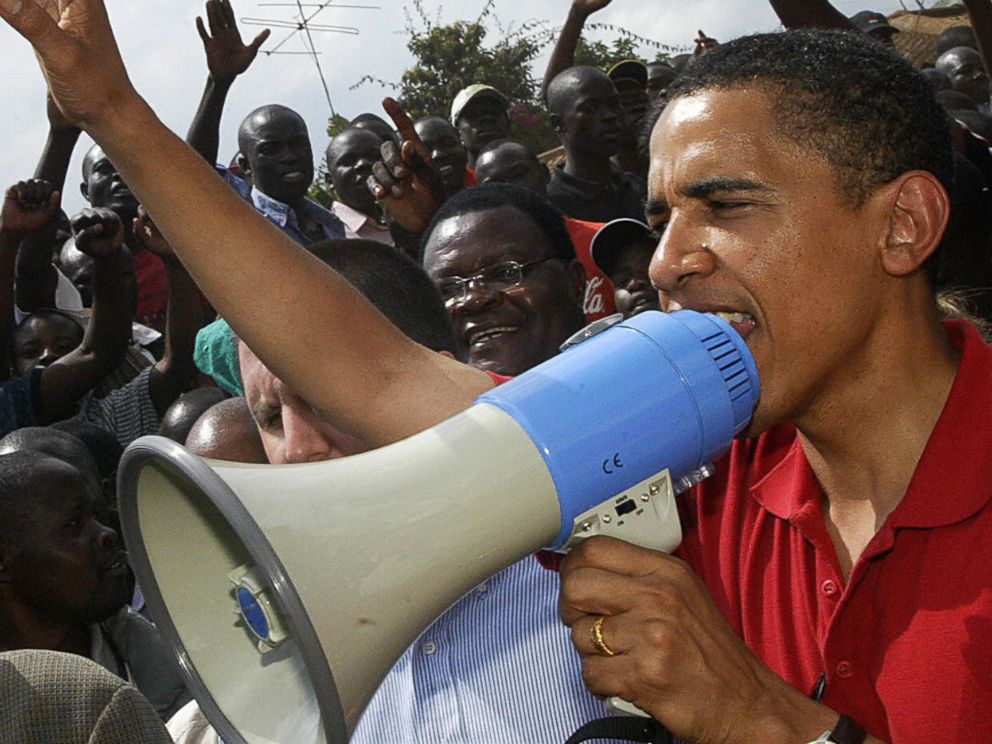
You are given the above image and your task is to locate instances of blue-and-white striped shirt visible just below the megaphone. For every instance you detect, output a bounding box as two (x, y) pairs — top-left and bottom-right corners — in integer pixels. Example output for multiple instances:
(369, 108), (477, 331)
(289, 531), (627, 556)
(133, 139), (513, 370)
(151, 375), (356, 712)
(351, 556), (607, 744)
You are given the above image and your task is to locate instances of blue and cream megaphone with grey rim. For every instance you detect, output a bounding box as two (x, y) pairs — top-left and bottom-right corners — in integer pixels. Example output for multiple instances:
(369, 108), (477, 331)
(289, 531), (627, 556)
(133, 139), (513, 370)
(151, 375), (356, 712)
(118, 311), (758, 744)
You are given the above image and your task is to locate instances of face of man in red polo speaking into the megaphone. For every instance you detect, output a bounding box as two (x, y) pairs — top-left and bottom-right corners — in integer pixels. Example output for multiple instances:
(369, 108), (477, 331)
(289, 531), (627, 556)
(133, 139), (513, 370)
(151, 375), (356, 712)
(647, 88), (890, 433)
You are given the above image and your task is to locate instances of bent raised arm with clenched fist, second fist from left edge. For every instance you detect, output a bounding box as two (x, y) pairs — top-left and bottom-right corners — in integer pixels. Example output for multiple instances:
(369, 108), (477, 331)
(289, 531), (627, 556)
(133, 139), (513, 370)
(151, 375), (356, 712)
(41, 209), (134, 421)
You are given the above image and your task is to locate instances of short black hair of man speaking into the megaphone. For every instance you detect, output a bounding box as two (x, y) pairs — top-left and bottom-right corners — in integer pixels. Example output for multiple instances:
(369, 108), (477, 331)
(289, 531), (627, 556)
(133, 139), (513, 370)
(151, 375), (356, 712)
(668, 30), (954, 206)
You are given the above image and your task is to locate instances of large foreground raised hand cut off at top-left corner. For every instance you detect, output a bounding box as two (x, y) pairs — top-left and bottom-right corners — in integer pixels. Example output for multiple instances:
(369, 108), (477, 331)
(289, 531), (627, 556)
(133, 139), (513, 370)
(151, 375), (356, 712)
(0, 0), (140, 131)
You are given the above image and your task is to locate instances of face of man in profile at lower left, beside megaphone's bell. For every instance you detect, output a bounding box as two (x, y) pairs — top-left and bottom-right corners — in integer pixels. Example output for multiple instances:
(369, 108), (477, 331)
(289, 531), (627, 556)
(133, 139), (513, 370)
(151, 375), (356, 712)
(3, 459), (130, 624)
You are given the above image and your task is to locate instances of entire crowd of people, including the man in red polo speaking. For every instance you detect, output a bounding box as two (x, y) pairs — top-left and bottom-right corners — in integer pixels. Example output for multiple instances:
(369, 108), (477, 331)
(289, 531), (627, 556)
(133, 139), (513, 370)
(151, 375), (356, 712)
(0, 0), (992, 744)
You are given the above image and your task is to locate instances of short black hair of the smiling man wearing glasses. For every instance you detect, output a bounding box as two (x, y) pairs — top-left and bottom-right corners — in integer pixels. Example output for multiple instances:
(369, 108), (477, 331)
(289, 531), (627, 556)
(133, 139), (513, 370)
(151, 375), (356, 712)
(421, 183), (575, 261)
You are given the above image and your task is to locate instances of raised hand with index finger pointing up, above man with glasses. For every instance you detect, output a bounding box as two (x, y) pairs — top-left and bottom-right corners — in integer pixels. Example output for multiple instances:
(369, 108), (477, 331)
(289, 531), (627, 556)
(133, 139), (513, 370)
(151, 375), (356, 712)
(368, 98), (444, 233)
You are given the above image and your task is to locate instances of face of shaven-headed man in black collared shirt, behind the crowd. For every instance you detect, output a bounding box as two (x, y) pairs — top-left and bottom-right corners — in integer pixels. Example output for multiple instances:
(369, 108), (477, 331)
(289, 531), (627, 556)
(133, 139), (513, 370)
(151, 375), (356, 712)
(559, 75), (623, 156)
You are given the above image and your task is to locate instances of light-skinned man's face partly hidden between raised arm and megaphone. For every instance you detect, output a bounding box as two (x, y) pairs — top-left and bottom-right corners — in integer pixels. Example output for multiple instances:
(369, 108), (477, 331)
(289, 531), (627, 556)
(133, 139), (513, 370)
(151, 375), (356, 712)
(238, 344), (368, 465)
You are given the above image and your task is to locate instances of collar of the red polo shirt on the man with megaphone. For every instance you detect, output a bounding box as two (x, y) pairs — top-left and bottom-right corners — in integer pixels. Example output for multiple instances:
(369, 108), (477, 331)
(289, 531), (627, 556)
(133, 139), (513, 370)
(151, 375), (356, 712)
(750, 320), (992, 529)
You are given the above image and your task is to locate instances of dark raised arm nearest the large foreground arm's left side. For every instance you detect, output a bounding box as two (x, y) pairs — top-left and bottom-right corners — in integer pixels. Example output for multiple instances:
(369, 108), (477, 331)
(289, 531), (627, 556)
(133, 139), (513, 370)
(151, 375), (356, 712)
(134, 208), (208, 417)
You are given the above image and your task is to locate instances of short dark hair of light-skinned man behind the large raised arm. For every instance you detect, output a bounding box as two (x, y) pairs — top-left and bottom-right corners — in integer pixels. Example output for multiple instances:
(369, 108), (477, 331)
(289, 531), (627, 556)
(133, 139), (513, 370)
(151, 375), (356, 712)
(307, 239), (456, 354)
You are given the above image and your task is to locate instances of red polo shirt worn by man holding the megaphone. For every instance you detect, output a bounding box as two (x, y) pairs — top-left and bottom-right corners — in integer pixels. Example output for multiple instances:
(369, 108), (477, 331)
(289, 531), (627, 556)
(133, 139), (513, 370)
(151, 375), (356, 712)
(679, 321), (992, 744)
